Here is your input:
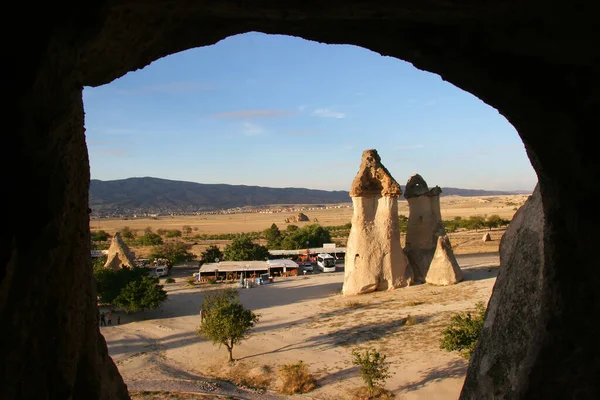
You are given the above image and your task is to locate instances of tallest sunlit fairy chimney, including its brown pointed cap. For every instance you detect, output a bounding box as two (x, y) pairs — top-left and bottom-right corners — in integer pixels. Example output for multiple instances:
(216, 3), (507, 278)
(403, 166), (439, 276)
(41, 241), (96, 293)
(343, 150), (412, 295)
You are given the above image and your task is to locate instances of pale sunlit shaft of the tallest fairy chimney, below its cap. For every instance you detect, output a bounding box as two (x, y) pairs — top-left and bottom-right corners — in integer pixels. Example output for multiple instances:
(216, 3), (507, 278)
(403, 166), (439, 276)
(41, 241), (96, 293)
(343, 196), (412, 295)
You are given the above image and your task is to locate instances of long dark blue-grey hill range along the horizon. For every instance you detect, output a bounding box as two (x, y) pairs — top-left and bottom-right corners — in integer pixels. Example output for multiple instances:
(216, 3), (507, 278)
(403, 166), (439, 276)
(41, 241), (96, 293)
(90, 177), (518, 212)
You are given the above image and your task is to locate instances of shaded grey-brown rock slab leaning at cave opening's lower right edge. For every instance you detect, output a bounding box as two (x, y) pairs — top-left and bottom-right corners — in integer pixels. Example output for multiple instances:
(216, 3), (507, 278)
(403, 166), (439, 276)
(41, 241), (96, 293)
(460, 187), (544, 400)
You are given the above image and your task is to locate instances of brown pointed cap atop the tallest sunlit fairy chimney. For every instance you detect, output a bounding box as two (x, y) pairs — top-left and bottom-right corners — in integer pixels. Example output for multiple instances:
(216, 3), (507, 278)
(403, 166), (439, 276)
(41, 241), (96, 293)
(350, 149), (402, 197)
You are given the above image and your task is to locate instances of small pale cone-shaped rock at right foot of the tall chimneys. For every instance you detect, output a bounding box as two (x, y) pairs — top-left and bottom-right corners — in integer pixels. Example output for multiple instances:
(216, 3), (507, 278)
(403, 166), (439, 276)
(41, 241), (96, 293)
(425, 235), (465, 286)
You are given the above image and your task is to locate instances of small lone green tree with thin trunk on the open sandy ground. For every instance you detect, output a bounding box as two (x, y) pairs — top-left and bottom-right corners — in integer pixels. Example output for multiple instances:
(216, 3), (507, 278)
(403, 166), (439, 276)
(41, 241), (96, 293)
(198, 289), (259, 361)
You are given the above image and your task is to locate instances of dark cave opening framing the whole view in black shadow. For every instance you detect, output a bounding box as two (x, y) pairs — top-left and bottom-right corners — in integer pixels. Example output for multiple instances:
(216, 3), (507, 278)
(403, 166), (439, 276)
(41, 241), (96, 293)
(0, 0), (600, 399)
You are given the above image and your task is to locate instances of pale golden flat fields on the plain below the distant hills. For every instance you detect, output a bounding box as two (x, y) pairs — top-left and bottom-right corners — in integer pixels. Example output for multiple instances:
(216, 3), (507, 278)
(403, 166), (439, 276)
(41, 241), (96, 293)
(90, 195), (528, 257)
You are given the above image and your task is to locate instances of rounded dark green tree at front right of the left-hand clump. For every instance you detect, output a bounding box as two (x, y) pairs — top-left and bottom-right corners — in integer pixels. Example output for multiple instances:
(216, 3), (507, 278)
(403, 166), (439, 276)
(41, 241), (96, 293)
(115, 276), (167, 313)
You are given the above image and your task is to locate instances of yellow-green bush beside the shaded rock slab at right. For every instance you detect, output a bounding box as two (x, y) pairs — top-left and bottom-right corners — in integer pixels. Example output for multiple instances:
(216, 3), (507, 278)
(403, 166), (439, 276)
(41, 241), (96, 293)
(440, 301), (485, 360)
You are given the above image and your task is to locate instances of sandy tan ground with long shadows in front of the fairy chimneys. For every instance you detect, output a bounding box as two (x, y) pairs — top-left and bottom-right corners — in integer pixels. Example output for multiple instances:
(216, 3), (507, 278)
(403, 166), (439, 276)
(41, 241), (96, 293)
(101, 254), (499, 400)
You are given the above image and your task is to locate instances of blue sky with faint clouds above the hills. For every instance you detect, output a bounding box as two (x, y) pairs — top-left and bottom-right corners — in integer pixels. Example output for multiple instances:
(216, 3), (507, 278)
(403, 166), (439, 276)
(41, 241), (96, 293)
(84, 33), (537, 190)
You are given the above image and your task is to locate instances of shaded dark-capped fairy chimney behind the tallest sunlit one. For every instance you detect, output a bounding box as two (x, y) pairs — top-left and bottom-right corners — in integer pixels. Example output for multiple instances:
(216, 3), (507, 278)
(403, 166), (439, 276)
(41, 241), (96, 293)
(404, 174), (452, 283)
